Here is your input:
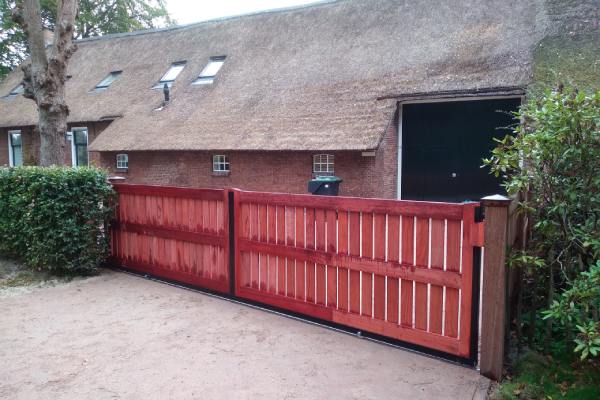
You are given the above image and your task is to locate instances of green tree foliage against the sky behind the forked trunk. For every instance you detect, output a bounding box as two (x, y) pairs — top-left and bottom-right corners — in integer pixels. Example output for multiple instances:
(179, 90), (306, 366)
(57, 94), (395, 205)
(0, 0), (174, 80)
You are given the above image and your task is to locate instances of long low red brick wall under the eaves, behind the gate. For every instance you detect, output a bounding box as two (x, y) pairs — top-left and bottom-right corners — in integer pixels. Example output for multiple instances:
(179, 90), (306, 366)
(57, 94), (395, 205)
(99, 136), (395, 198)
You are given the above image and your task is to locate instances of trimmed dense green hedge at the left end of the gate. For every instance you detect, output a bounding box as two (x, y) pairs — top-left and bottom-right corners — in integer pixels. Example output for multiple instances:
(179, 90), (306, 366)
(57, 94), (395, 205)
(0, 167), (114, 273)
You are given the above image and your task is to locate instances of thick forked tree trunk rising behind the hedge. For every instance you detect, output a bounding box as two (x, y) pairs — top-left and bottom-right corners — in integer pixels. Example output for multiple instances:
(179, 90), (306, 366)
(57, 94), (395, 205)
(13, 0), (78, 166)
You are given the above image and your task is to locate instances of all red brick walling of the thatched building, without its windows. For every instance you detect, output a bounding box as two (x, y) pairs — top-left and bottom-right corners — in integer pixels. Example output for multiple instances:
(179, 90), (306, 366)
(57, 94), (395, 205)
(0, 116), (398, 198)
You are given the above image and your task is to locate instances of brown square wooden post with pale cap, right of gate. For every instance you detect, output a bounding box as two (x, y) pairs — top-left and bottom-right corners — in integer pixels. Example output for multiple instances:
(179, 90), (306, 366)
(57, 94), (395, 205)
(479, 195), (511, 380)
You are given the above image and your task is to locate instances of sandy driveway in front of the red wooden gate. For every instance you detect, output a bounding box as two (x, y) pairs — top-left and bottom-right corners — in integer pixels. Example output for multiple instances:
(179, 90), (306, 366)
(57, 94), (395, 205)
(0, 272), (488, 400)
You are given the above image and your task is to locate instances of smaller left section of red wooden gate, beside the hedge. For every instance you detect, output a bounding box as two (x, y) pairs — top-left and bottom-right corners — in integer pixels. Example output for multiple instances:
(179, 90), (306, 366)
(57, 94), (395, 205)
(112, 184), (229, 293)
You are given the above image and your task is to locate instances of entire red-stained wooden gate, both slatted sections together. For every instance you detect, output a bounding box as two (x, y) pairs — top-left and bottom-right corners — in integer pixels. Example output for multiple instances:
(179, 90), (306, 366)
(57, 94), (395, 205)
(112, 184), (483, 358)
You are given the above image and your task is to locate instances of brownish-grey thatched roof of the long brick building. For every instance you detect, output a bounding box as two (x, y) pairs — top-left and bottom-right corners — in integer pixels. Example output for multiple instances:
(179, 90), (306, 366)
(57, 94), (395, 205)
(0, 0), (543, 151)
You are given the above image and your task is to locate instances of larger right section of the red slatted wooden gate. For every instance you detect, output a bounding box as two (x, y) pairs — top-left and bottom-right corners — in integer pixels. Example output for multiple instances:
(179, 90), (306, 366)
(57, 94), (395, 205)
(234, 190), (483, 357)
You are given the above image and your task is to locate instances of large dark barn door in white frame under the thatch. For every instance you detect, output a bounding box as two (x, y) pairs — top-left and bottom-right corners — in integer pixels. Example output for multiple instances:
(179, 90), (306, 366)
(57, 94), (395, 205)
(401, 98), (521, 202)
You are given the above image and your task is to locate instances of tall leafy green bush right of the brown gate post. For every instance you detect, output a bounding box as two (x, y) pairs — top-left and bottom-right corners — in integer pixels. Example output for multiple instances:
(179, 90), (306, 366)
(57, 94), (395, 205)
(484, 88), (600, 355)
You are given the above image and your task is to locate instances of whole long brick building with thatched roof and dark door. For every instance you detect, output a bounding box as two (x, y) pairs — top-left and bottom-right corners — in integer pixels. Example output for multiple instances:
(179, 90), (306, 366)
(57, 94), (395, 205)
(0, 0), (593, 200)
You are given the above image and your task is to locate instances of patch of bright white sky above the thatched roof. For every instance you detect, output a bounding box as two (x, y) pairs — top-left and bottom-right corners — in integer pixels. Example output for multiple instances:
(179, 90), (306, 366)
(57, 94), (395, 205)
(166, 0), (324, 25)
